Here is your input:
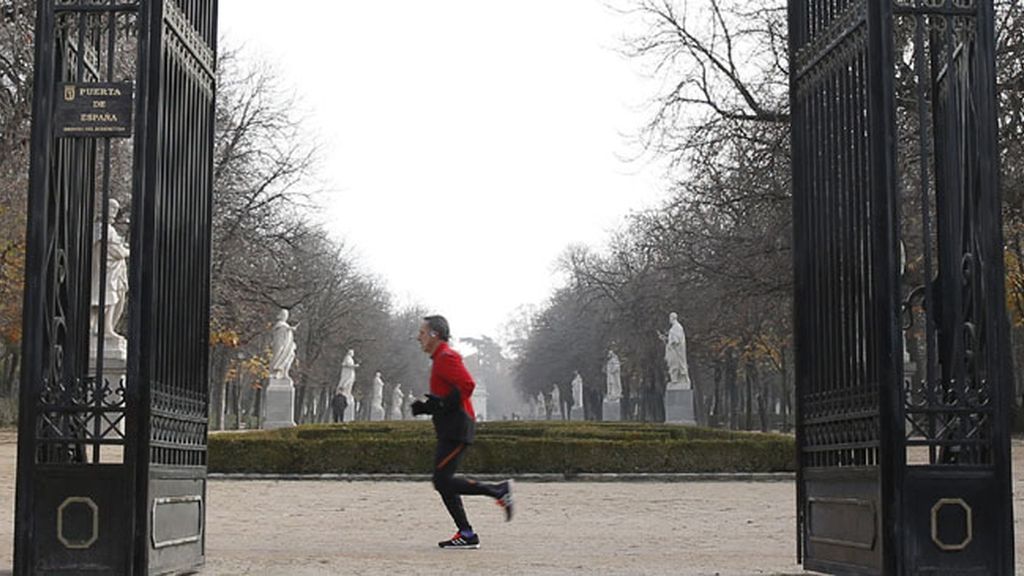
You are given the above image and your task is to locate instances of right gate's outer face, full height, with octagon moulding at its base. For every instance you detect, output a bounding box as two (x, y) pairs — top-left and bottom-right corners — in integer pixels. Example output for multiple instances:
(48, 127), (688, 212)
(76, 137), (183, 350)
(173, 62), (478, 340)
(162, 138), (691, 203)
(893, 0), (1014, 574)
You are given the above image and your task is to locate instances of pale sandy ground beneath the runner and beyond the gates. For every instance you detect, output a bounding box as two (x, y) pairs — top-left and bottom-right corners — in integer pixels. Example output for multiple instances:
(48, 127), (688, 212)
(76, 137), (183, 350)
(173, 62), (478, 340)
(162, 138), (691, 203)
(0, 433), (1024, 576)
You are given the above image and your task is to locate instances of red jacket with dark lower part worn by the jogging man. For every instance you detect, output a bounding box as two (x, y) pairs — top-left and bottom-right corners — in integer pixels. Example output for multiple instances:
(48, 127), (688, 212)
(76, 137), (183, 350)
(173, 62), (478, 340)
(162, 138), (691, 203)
(430, 341), (476, 442)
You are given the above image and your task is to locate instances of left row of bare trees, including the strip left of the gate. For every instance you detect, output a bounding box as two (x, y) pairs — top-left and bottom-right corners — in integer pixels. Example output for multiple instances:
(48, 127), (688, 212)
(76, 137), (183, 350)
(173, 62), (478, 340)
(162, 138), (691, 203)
(0, 0), (429, 427)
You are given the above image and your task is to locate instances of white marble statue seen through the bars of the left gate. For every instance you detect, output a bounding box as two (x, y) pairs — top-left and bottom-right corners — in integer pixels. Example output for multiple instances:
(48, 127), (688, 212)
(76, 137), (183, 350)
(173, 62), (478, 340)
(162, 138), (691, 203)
(89, 198), (129, 342)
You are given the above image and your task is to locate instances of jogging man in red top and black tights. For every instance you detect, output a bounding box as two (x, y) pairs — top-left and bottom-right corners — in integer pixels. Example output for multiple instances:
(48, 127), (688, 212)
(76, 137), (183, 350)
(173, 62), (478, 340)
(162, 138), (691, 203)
(412, 316), (512, 548)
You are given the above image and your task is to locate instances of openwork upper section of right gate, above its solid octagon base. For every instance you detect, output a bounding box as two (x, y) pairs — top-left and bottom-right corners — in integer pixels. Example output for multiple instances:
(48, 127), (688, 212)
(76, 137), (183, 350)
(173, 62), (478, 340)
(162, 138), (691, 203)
(897, 0), (999, 466)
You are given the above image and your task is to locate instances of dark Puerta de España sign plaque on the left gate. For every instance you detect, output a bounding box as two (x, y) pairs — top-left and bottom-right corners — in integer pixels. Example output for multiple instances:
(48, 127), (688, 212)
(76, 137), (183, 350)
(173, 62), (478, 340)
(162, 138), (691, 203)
(54, 82), (132, 138)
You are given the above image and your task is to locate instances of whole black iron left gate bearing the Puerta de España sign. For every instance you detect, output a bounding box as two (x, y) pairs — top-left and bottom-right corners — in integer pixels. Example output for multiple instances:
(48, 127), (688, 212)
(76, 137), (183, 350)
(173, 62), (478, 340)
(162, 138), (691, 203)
(14, 0), (217, 575)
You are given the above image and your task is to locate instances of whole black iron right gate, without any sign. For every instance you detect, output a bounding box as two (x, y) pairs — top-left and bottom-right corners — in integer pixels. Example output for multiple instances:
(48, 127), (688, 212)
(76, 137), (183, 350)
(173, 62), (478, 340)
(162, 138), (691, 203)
(790, 0), (1014, 576)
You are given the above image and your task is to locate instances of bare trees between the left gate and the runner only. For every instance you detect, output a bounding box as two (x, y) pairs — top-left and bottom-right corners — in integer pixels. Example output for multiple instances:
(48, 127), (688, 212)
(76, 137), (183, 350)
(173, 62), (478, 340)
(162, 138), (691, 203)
(205, 51), (427, 425)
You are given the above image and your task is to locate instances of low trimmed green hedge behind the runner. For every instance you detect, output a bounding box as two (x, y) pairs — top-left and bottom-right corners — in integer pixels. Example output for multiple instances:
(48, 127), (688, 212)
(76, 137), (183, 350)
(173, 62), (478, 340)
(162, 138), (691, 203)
(209, 421), (795, 475)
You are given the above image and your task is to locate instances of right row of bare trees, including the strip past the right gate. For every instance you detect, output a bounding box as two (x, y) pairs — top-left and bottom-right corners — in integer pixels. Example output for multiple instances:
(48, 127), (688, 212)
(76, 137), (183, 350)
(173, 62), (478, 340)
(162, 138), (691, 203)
(515, 0), (1024, 429)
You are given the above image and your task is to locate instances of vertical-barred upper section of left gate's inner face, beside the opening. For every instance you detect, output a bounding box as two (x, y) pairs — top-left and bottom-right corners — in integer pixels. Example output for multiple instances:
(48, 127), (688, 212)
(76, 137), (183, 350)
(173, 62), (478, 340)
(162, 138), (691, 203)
(138, 0), (215, 467)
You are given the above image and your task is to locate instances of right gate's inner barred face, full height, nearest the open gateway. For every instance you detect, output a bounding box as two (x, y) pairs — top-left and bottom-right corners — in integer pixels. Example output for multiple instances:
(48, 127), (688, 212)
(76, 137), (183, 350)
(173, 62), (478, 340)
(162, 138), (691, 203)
(790, 0), (895, 574)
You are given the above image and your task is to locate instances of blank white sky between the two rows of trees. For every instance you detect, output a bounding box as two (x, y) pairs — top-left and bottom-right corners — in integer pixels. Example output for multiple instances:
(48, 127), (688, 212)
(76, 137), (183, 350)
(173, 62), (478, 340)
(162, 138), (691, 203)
(220, 0), (664, 337)
